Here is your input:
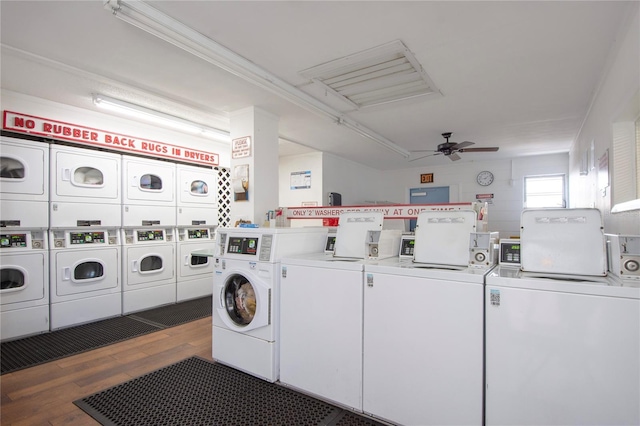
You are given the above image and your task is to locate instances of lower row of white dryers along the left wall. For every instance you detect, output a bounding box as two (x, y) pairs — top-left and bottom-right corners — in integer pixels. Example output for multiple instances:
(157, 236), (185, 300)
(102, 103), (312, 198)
(0, 227), (215, 340)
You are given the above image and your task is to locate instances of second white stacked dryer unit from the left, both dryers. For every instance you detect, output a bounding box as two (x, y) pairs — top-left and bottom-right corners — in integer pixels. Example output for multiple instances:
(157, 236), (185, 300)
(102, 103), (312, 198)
(49, 144), (122, 330)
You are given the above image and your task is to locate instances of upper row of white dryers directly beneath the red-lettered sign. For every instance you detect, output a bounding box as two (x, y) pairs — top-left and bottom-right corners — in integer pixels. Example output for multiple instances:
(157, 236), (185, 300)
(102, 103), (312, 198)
(0, 137), (217, 229)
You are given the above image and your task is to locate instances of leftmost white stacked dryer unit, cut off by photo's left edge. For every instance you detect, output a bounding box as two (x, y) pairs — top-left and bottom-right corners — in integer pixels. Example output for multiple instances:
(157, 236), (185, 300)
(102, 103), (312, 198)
(0, 137), (50, 340)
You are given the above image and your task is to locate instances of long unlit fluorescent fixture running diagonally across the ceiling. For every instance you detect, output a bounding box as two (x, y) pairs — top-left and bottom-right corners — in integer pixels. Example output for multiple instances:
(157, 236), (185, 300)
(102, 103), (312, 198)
(104, 0), (409, 157)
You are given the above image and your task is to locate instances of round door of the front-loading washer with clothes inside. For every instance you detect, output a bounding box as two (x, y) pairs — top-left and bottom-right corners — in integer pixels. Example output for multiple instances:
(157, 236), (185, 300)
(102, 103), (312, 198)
(214, 270), (272, 332)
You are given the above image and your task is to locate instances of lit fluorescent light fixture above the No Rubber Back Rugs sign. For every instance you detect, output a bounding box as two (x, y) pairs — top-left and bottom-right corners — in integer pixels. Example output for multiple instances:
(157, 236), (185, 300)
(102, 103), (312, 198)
(93, 94), (231, 142)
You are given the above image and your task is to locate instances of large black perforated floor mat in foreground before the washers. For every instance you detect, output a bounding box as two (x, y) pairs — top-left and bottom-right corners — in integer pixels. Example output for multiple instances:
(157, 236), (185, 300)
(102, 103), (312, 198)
(74, 357), (382, 426)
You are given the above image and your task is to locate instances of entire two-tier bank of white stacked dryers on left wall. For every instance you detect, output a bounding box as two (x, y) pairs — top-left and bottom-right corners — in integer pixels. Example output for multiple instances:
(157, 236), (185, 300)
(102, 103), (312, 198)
(0, 137), (217, 340)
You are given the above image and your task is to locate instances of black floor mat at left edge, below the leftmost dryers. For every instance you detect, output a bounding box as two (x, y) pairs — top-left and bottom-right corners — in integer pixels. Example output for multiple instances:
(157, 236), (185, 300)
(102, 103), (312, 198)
(0, 317), (161, 374)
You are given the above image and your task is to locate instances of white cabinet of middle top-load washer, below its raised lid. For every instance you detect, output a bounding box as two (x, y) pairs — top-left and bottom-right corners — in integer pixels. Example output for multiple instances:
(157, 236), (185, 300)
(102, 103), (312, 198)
(362, 260), (491, 425)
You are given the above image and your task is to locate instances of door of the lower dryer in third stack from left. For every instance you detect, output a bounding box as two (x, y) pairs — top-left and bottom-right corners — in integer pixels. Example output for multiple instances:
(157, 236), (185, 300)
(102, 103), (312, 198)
(124, 244), (176, 288)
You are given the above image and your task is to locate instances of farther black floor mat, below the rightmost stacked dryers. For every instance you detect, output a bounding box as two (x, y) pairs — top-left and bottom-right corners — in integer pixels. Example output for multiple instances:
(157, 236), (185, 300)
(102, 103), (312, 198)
(129, 296), (212, 327)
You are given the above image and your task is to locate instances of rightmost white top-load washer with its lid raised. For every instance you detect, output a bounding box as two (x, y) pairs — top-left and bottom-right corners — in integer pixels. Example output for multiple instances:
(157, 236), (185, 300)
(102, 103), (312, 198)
(485, 209), (640, 425)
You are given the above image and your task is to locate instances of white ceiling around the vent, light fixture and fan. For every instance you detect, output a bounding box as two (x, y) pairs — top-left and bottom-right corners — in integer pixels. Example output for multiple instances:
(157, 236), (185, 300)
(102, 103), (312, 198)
(0, 0), (633, 170)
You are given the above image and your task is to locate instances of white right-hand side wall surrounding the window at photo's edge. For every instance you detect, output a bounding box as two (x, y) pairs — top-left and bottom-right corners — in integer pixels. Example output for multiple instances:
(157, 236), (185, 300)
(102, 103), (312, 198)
(570, 2), (640, 235)
